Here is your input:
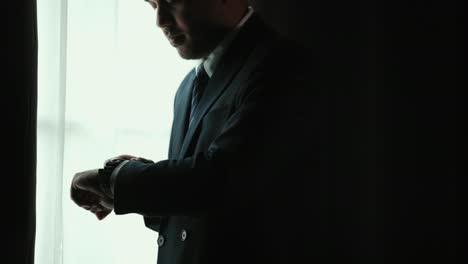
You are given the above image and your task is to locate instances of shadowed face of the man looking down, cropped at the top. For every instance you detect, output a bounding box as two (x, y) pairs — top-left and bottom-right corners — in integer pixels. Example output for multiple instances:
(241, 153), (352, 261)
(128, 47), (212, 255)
(146, 0), (228, 59)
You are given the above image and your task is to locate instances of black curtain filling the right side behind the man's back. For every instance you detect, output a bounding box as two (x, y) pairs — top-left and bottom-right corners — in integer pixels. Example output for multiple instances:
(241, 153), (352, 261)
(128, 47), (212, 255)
(253, 0), (458, 263)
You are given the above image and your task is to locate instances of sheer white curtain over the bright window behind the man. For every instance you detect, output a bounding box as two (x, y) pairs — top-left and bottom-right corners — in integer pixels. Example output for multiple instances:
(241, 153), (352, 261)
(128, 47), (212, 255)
(36, 0), (195, 264)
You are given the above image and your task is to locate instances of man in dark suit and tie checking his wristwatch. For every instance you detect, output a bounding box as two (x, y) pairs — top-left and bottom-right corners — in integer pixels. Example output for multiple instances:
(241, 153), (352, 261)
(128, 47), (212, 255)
(71, 0), (317, 264)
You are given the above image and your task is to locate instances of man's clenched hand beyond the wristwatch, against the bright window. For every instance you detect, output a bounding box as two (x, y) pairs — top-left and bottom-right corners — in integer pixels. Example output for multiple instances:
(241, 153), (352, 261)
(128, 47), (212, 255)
(70, 169), (114, 220)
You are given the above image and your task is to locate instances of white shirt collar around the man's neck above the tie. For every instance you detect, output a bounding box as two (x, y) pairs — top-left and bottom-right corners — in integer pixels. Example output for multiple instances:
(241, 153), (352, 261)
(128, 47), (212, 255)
(196, 6), (254, 78)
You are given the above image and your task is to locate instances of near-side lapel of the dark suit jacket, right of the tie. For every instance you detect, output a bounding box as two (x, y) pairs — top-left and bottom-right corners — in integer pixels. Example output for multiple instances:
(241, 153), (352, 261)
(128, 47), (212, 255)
(179, 15), (264, 158)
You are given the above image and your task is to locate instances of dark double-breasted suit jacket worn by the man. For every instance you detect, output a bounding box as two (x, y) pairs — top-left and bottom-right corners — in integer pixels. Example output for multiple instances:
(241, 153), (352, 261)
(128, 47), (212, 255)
(115, 14), (314, 264)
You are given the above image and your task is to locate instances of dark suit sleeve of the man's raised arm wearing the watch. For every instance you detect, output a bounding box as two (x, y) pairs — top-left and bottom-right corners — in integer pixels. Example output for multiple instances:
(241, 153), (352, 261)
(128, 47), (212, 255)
(114, 59), (312, 217)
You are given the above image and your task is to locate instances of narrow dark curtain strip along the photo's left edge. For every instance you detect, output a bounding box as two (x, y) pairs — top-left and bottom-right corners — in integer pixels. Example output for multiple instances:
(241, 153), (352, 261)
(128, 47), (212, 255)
(5, 0), (37, 264)
